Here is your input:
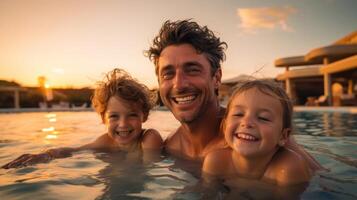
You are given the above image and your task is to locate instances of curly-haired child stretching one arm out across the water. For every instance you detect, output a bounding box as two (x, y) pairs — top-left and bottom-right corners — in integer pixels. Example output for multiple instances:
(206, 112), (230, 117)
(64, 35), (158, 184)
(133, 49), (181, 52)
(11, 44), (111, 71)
(2, 69), (163, 168)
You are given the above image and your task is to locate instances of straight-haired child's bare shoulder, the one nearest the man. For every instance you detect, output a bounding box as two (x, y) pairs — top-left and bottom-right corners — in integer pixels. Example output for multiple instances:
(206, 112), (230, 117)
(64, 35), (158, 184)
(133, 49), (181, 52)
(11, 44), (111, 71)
(202, 148), (234, 176)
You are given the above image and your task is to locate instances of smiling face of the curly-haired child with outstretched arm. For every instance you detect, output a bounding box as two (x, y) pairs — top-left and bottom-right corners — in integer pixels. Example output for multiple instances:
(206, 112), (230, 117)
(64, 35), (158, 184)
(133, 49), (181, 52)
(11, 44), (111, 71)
(105, 96), (144, 146)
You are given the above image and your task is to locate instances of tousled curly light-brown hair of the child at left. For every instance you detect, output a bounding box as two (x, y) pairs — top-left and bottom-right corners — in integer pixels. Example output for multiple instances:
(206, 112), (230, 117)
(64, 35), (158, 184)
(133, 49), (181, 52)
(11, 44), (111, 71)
(92, 68), (156, 123)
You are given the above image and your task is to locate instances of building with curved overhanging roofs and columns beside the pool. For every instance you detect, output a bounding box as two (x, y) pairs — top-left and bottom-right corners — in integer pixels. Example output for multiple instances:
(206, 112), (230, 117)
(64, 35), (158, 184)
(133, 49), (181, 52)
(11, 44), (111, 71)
(275, 31), (357, 106)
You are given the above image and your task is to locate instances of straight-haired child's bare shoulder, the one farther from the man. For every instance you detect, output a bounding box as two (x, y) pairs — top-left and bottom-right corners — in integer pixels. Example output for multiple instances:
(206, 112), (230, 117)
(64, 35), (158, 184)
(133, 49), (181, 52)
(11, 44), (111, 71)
(265, 148), (312, 185)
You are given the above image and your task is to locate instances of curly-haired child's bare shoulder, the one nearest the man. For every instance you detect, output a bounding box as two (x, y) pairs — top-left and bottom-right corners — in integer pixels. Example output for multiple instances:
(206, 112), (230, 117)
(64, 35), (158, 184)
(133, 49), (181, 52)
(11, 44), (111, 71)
(141, 129), (163, 149)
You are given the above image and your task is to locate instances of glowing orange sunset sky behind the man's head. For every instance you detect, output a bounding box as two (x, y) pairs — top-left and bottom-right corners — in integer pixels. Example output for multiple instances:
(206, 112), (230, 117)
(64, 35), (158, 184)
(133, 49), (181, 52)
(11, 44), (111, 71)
(0, 0), (357, 87)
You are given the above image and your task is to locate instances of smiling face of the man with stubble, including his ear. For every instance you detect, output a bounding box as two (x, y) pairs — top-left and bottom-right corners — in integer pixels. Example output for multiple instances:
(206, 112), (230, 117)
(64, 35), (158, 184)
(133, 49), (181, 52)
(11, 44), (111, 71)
(158, 44), (221, 123)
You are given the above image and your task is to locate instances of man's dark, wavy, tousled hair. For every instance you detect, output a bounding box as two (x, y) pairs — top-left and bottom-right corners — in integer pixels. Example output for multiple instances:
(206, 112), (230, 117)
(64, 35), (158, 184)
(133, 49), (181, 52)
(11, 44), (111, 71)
(146, 19), (228, 76)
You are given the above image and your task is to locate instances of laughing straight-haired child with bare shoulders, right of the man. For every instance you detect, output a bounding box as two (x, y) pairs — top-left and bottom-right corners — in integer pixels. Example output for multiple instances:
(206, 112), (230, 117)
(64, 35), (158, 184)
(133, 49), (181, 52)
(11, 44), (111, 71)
(203, 80), (312, 185)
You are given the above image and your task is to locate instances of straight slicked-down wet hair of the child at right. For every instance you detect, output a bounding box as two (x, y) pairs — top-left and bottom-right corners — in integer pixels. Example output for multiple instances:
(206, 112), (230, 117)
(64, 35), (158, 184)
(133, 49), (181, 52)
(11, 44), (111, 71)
(221, 79), (293, 131)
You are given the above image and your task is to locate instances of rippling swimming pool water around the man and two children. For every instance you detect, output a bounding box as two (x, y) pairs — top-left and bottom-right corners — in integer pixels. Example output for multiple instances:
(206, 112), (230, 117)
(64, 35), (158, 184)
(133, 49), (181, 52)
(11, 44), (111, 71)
(0, 111), (357, 199)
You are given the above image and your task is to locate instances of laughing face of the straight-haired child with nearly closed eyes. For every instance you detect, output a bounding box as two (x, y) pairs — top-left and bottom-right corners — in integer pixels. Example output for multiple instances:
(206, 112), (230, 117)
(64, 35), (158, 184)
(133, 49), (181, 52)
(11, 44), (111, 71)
(224, 88), (288, 157)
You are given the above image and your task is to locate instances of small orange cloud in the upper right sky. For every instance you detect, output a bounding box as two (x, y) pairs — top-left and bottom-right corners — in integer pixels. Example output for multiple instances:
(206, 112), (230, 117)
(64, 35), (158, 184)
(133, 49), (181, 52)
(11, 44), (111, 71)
(237, 6), (296, 33)
